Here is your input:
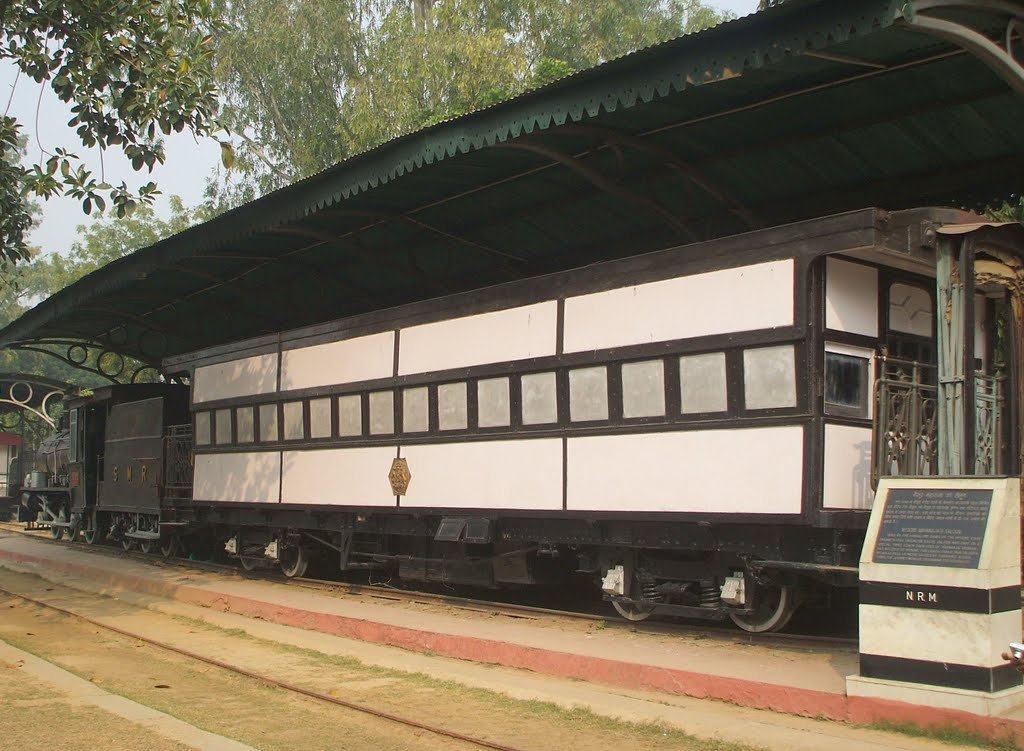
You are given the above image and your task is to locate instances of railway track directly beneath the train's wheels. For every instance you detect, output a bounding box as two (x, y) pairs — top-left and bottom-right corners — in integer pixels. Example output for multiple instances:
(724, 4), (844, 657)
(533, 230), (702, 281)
(0, 523), (858, 651)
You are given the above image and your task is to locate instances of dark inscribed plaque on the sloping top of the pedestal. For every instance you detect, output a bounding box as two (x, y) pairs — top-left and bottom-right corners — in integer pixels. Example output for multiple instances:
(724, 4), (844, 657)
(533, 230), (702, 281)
(873, 488), (992, 569)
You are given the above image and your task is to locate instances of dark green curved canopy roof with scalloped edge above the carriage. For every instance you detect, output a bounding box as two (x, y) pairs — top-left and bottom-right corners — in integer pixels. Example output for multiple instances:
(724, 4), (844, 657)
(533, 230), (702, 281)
(0, 0), (1024, 363)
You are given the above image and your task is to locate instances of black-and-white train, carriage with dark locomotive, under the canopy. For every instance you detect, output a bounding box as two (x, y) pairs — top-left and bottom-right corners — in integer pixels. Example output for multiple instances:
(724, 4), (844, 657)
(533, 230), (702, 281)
(29, 209), (1024, 631)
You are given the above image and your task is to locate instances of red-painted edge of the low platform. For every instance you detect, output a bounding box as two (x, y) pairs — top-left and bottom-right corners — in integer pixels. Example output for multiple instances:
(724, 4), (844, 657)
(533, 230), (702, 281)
(6, 549), (1024, 743)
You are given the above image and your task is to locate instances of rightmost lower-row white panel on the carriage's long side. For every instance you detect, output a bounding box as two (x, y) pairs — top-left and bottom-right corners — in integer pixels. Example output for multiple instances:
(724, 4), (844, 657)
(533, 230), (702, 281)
(567, 425), (804, 514)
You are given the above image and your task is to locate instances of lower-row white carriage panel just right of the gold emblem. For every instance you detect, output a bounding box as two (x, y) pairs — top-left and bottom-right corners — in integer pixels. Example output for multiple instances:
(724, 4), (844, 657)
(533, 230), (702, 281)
(401, 439), (562, 510)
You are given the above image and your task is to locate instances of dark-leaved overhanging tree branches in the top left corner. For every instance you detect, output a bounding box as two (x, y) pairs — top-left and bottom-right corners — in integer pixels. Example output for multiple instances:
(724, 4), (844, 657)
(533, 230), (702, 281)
(0, 0), (230, 264)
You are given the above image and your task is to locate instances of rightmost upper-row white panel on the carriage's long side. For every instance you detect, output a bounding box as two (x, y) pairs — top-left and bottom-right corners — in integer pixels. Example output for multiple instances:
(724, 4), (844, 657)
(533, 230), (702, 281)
(564, 258), (794, 352)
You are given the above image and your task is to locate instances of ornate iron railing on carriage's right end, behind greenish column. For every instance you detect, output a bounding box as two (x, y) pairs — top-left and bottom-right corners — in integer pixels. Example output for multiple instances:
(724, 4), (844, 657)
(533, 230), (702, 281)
(871, 357), (1005, 487)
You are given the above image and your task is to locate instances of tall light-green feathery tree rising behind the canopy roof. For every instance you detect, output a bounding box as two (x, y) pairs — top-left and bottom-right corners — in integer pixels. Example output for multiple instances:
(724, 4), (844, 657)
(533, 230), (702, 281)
(211, 0), (726, 202)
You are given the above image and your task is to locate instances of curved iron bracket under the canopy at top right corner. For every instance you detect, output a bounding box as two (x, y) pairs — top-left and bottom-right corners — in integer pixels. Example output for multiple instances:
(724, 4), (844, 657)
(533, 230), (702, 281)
(903, 0), (1024, 94)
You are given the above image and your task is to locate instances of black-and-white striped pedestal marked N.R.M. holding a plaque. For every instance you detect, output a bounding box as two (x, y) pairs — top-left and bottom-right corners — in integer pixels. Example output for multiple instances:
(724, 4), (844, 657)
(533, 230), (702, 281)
(847, 477), (1024, 715)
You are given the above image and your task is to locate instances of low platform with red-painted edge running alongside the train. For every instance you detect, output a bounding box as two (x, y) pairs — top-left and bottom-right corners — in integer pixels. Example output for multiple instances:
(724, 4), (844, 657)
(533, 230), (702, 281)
(0, 532), (1024, 742)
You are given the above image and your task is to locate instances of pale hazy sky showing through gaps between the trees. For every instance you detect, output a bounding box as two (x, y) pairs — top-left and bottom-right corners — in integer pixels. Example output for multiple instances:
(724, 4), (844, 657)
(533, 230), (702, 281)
(0, 0), (758, 259)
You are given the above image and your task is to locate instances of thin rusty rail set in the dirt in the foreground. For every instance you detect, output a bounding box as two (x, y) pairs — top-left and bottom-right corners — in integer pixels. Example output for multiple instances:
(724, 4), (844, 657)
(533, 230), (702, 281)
(0, 587), (522, 751)
